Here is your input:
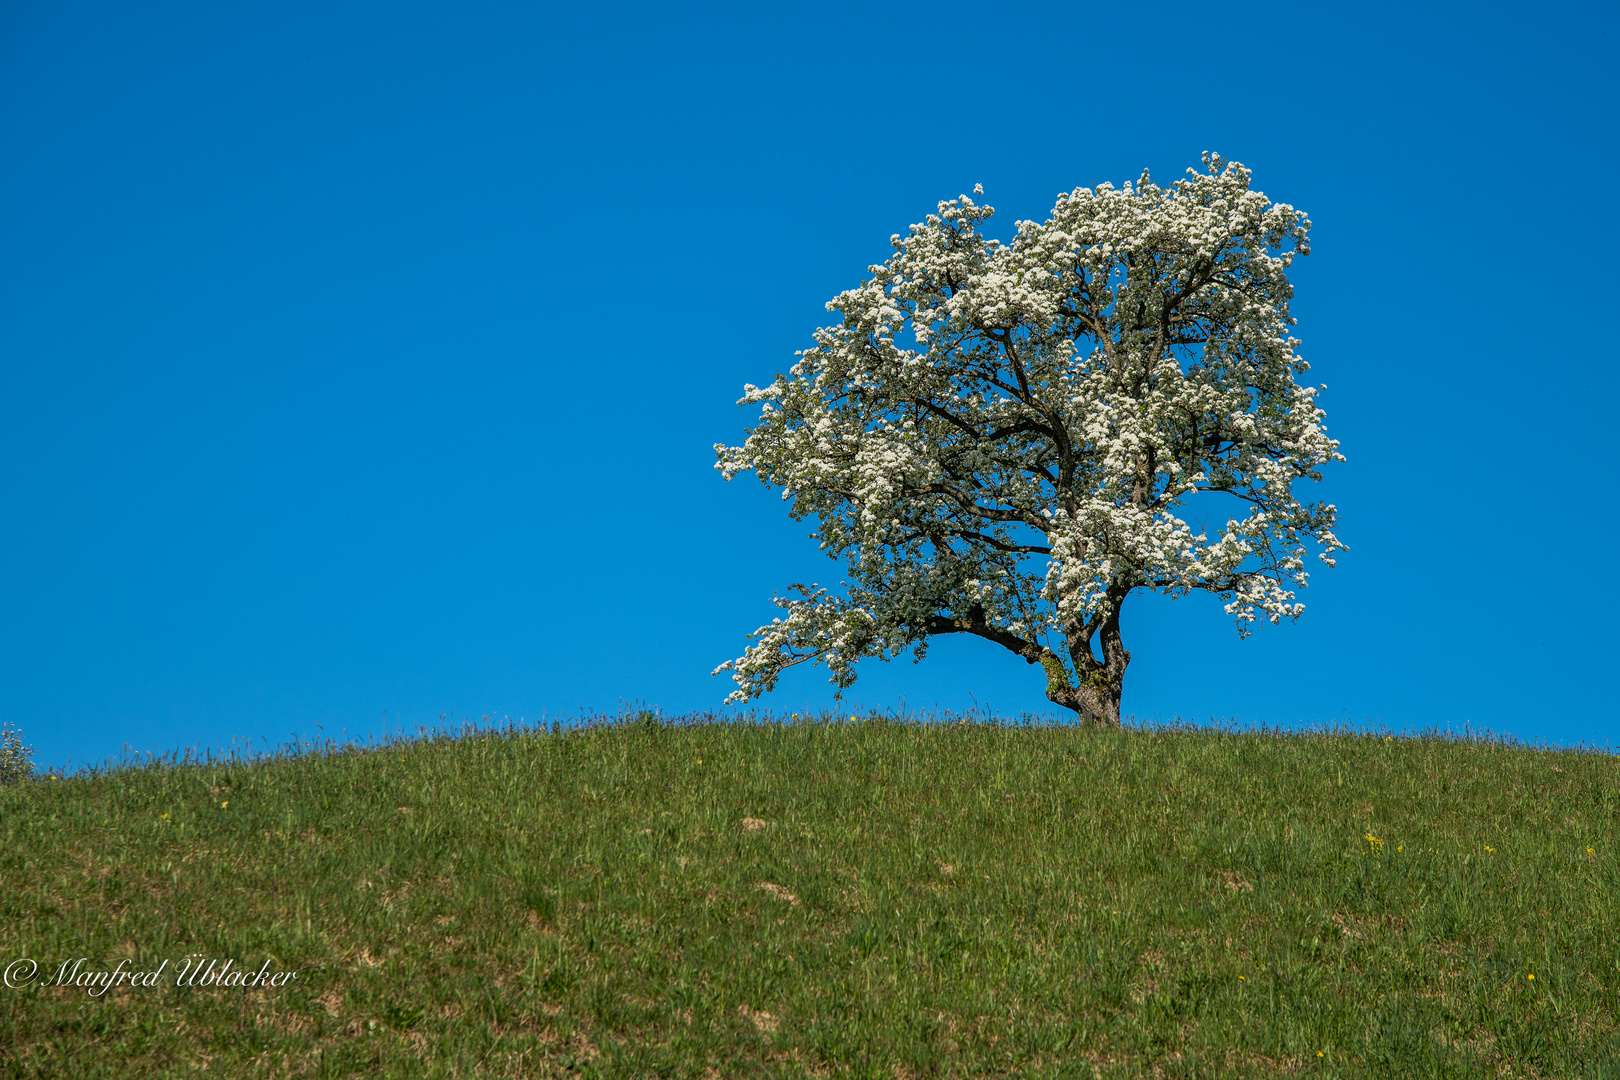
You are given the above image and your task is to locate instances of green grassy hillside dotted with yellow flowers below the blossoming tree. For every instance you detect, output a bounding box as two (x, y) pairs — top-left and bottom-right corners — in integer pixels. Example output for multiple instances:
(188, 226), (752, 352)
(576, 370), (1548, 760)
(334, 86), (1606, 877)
(0, 717), (1620, 1078)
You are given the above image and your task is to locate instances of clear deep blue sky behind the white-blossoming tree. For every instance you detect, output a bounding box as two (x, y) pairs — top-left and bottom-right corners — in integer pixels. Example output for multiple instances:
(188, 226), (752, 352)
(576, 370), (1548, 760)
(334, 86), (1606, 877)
(0, 0), (1620, 764)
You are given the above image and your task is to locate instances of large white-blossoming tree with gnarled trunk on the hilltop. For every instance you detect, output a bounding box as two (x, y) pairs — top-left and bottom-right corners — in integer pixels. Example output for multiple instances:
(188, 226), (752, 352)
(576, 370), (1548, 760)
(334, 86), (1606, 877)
(714, 154), (1345, 725)
